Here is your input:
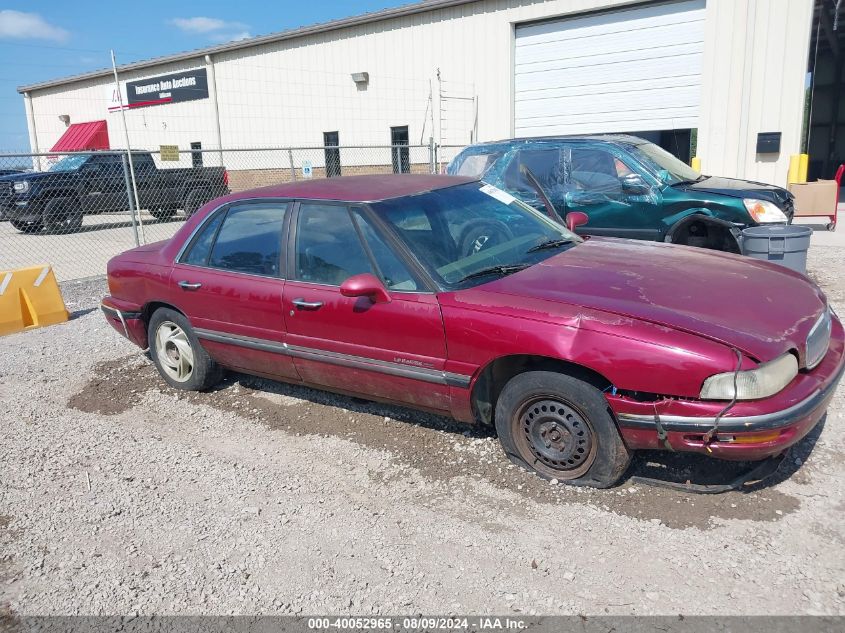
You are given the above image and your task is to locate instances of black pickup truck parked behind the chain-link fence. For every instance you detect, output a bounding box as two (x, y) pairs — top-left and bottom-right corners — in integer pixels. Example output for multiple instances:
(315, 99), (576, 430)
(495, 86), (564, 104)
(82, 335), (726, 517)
(0, 151), (229, 233)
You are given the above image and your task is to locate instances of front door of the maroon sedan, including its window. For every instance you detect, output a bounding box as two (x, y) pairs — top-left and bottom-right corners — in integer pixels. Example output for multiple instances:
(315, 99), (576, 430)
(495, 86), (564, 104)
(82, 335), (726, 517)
(284, 202), (449, 411)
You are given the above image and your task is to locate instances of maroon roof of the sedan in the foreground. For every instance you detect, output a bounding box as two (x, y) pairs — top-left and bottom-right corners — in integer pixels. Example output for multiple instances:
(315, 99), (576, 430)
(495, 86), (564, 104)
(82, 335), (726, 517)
(229, 174), (476, 202)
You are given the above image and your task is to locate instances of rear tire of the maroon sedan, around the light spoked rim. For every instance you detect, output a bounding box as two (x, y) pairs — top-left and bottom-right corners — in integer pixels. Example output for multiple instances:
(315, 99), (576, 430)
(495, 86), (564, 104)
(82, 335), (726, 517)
(147, 308), (225, 391)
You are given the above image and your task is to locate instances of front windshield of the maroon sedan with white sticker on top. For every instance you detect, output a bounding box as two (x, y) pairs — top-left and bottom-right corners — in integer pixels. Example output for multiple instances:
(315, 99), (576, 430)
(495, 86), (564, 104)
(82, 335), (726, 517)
(373, 182), (582, 289)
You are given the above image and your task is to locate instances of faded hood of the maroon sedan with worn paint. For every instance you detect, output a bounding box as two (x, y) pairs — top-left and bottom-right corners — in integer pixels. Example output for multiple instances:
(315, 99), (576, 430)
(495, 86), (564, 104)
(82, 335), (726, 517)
(478, 238), (826, 362)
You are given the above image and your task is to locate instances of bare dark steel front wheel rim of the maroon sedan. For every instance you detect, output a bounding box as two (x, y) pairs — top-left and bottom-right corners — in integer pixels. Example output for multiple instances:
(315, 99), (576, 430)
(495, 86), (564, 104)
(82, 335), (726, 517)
(512, 396), (597, 480)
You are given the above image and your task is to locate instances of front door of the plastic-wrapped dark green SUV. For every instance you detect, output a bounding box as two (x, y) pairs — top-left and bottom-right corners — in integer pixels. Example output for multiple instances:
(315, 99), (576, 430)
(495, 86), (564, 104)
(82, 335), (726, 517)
(564, 143), (662, 240)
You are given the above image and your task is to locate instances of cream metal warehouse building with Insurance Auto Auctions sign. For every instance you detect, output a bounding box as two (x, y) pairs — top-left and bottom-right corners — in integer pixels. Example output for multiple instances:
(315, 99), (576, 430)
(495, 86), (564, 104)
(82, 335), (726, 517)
(14, 0), (845, 184)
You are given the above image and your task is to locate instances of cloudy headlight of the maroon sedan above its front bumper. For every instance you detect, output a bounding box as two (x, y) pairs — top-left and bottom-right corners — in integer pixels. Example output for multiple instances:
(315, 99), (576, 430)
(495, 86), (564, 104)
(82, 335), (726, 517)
(701, 352), (798, 400)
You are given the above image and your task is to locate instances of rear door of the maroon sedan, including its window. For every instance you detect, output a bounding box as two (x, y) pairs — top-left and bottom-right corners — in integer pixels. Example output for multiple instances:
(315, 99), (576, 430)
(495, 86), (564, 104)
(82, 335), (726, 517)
(169, 201), (299, 379)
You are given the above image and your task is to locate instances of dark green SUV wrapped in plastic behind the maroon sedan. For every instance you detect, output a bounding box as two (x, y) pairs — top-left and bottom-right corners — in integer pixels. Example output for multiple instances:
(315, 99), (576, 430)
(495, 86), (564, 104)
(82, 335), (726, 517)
(447, 135), (794, 253)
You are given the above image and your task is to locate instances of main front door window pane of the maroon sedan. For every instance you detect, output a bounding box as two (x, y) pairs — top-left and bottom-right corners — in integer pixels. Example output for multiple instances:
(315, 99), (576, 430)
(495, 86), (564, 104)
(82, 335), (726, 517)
(295, 203), (375, 286)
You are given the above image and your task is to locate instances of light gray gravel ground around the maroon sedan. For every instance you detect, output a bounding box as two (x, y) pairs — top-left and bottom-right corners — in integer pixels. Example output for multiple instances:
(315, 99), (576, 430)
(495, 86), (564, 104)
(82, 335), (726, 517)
(0, 246), (845, 615)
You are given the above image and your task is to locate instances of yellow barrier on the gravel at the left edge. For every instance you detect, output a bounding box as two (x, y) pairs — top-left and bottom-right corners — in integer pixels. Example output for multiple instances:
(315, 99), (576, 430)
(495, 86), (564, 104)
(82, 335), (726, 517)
(0, 266), (70, 336)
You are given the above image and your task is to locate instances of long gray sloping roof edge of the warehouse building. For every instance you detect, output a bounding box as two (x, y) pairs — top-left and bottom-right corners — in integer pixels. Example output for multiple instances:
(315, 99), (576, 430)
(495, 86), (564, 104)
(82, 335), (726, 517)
(17, 0), (480, 94)
